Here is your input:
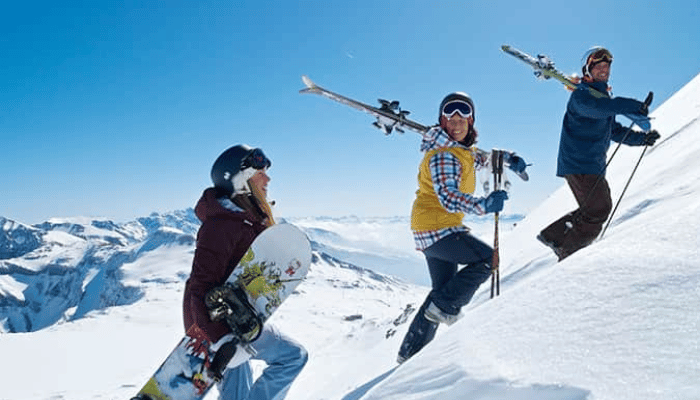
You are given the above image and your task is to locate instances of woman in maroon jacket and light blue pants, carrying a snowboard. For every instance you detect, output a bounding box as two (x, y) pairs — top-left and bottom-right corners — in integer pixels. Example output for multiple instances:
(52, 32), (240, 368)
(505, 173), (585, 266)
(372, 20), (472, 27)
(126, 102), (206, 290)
(183, 145), (308, 400)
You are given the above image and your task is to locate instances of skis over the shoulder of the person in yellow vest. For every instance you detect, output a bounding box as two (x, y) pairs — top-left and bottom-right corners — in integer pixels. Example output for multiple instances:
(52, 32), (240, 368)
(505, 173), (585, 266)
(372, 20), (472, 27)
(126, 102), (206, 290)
(299, 75), (529, 181)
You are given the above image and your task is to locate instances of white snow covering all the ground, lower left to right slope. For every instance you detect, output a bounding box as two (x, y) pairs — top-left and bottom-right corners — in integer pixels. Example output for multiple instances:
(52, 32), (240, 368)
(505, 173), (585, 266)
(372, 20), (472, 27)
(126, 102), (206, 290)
(0, 75), (700, 400)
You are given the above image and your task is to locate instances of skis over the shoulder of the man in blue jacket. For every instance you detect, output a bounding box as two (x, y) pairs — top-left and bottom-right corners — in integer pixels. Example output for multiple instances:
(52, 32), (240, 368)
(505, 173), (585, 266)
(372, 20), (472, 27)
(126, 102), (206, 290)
(501, 44), (651, 132)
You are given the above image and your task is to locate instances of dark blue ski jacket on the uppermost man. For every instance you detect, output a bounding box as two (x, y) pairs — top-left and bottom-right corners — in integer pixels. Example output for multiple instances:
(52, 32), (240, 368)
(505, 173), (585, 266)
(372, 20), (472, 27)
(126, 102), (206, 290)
(557, 82), (645, 176)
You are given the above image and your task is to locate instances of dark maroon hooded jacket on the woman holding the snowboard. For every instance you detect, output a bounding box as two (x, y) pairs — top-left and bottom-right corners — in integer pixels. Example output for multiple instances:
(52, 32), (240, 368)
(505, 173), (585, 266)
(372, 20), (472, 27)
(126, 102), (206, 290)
(183, 188), (265, 342)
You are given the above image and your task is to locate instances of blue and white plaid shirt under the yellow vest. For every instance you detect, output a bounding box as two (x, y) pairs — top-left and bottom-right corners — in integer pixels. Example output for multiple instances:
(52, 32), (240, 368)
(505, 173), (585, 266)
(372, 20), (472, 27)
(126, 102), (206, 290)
(413, 127), (488, 251)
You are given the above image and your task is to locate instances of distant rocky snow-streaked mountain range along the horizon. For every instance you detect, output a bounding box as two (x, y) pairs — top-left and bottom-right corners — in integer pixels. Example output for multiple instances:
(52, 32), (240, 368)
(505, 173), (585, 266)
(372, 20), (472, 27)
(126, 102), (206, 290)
(0, 208), (448, 332)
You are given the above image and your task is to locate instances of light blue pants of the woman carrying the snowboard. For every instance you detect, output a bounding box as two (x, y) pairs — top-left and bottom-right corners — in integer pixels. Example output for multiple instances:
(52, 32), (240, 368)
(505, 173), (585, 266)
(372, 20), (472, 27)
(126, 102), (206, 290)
(218, 324), (309, 400)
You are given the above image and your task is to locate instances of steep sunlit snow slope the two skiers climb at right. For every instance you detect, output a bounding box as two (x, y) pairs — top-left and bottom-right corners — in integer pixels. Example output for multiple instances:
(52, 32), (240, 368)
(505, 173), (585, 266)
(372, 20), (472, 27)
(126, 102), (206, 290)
(362, 75), (700, 400)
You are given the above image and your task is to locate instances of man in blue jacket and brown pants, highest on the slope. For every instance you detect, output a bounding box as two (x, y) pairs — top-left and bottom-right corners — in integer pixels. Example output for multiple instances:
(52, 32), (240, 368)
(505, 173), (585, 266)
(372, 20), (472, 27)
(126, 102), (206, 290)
(537, 47), (660, 261)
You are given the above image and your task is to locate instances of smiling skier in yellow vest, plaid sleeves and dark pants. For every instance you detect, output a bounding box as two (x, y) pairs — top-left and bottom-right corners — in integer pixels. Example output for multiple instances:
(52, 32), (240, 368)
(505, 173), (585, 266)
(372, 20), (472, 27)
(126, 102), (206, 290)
(397, 92), (526, 363)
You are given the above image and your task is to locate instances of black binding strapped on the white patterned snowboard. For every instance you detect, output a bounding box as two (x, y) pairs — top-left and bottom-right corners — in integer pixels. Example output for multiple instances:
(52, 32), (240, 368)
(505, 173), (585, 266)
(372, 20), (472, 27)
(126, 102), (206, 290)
(204, 283), (263, 343)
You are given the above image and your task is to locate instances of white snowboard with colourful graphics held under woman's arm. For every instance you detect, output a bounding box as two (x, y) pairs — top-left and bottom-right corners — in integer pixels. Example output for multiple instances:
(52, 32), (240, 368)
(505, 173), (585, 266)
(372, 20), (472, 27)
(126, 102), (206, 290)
(132, 224), (311, 400)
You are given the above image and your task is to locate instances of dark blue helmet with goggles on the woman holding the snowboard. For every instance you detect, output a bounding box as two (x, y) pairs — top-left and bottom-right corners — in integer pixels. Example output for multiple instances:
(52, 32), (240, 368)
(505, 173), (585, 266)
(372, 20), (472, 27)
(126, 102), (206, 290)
(211, 144), (272, 196)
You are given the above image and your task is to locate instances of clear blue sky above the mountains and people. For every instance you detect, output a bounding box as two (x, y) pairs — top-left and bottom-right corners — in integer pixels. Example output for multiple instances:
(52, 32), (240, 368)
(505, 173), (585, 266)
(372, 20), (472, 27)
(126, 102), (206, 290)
(0, 0), (700, 223)
